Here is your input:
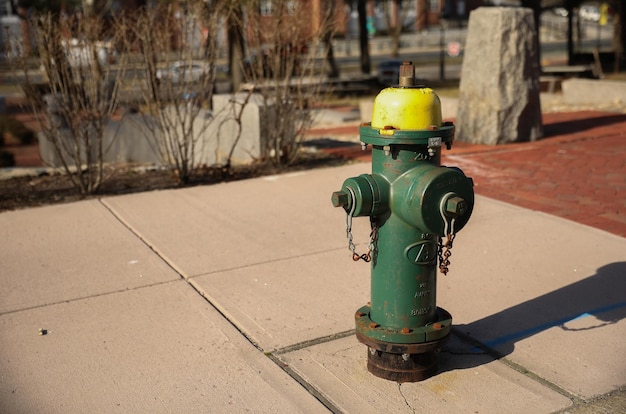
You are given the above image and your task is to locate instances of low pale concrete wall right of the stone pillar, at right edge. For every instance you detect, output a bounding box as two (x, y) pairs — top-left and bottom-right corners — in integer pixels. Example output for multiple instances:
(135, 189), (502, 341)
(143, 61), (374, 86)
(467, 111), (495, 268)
(561, 78), (626, 104)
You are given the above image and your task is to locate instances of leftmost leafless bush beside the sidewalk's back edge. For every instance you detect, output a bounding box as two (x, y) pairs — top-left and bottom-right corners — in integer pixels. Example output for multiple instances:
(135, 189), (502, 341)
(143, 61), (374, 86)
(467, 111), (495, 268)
(13, 13), (125, 194)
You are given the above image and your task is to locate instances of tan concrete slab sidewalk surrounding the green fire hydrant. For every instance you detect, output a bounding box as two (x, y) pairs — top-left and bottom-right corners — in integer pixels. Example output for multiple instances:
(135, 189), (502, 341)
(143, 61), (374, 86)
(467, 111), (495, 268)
(0, 163), (626, 413)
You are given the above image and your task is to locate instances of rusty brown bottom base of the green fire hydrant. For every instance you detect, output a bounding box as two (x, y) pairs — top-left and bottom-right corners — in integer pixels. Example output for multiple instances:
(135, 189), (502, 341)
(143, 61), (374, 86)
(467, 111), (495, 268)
(356, 332), (450, 383)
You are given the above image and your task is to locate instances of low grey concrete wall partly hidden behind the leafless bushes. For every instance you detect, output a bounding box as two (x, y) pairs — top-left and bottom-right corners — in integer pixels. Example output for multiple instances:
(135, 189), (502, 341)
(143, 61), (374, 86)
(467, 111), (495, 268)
(39, 94), (278, 167)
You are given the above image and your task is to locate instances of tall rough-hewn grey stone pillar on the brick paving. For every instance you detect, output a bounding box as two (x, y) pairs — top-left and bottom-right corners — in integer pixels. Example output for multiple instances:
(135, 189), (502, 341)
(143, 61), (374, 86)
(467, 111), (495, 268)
(455, 7), (543, 145)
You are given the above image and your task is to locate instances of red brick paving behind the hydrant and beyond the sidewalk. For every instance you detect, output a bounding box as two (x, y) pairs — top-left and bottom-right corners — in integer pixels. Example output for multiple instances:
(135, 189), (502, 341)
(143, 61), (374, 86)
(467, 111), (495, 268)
(314, 111), (626, 237)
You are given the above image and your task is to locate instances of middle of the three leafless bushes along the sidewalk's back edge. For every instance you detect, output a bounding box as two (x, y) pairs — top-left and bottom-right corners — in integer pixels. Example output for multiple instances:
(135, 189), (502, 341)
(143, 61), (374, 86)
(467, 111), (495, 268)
(126, 0), (229, 183)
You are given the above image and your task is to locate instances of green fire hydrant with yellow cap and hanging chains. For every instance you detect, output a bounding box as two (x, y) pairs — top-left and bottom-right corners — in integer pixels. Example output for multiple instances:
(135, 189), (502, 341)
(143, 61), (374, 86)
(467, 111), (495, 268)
(331, 62), (474, 382)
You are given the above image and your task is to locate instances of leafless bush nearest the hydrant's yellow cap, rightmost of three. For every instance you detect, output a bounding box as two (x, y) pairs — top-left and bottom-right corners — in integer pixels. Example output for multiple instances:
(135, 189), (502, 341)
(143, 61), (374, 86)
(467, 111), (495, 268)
(243, 0), (331, 165)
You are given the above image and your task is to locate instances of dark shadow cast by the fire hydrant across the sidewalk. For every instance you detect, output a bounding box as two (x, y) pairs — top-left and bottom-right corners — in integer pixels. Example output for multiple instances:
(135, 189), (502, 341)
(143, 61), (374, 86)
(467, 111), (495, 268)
(439, 262), (626, 371)
